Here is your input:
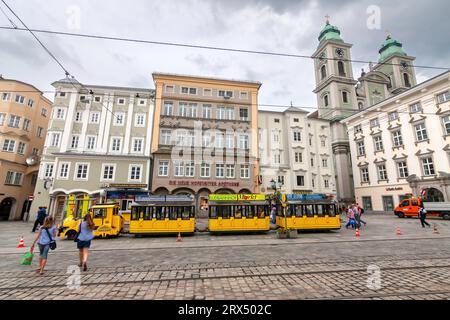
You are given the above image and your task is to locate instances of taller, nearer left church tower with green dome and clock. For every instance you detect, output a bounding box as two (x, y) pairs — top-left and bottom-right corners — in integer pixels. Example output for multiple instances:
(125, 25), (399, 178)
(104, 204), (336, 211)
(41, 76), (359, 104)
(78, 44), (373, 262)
(312, 17), (358, 202)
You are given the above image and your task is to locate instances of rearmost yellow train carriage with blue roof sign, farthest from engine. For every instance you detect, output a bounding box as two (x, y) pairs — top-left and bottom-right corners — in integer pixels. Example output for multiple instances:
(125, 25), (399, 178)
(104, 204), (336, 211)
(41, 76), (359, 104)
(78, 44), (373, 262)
(276, 194), (341, 231)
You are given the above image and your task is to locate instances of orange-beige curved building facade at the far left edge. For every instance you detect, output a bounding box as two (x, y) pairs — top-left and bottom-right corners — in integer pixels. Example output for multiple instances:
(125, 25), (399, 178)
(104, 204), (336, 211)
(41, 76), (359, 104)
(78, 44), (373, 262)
(0, 77), (52, 220)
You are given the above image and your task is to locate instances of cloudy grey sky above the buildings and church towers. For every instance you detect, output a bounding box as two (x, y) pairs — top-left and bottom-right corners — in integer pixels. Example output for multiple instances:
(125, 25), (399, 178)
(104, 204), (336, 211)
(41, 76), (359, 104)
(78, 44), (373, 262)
(0, 0), (450, 108)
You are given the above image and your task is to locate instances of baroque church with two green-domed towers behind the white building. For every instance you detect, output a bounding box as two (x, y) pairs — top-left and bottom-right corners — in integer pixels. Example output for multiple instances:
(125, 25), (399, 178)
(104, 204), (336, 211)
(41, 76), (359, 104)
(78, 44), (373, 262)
(312, 19), (417, 203)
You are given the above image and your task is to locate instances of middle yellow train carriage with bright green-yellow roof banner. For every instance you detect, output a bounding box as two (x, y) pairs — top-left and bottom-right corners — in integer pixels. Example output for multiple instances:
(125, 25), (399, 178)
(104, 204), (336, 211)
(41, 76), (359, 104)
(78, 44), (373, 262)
(208, 194), (270, 233)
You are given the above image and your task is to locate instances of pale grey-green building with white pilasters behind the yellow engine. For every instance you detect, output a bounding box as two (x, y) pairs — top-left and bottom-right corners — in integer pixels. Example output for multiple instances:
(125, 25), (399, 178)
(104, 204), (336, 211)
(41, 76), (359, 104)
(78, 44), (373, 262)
(31, 78), (154, 219)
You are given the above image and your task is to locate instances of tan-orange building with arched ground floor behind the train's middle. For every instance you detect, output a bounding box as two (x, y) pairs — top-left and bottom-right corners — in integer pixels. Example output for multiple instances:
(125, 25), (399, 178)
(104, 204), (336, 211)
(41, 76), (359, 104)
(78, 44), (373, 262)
(151, 73), (261, 215)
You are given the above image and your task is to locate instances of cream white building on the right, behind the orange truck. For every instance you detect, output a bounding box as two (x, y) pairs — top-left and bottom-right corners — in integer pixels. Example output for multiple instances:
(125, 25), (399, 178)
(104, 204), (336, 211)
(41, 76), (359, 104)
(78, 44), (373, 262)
(343, 72), (450, 211)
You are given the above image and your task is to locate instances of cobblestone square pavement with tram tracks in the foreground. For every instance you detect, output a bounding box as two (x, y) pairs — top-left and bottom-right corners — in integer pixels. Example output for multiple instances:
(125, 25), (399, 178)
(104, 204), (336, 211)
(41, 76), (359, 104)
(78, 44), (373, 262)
(0, 216), (450, 300)
